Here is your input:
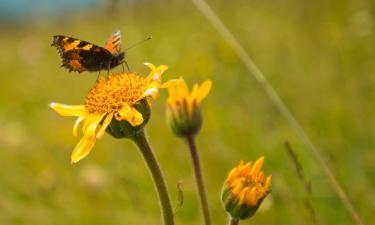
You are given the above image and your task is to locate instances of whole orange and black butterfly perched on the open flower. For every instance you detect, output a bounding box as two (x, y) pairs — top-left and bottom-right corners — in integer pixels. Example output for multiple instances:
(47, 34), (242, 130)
(51, 31), (129, 73)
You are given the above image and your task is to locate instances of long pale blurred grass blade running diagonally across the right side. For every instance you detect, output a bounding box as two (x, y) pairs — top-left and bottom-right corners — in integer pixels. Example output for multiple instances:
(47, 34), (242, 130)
(192, 0), (363, 225)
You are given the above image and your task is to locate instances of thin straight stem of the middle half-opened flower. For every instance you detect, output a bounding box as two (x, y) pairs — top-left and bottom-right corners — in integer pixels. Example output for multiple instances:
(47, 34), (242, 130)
(186, 135), (211, 225)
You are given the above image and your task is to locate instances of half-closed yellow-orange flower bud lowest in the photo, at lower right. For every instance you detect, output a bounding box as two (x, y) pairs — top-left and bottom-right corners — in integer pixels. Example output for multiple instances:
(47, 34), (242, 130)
(222, 157), (272, 219)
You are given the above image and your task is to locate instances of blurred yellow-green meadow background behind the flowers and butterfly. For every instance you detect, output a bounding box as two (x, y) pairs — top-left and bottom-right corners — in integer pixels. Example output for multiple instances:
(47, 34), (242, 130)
(0, 0), (375, 225)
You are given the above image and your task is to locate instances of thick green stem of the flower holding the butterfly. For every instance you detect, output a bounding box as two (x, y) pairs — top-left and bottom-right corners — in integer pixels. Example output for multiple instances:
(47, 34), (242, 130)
(132, 129), (174, 225)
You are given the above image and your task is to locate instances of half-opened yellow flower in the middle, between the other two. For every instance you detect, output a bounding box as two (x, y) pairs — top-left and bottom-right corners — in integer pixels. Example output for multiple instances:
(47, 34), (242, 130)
(164, 78), (212, 136)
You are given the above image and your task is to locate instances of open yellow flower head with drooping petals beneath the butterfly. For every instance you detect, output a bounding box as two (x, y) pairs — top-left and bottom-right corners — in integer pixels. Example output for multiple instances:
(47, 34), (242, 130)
(49, 63), (168, 163)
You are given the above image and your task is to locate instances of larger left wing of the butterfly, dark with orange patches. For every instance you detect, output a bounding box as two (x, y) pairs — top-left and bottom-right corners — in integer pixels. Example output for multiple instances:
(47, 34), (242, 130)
(51, 35), (112, 73)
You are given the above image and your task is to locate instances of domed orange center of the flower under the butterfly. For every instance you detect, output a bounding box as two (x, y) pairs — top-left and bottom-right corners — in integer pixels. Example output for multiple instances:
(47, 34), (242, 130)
(85, 72), (148, 113)
